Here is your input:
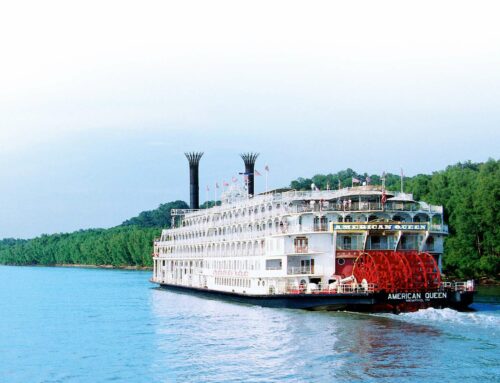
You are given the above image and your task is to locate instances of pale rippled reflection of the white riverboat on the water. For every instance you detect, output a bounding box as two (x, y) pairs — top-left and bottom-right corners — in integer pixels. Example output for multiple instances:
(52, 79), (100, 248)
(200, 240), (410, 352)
(152, 290), (452, 382)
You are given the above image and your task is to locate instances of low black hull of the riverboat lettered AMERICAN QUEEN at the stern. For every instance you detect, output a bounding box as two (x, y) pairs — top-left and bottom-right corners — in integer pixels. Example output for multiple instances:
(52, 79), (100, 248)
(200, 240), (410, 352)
(154, 283), (474, 313)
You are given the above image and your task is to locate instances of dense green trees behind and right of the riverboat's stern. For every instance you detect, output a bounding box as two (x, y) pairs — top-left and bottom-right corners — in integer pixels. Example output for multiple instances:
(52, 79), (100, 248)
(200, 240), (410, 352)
(290, 159), (500, 280)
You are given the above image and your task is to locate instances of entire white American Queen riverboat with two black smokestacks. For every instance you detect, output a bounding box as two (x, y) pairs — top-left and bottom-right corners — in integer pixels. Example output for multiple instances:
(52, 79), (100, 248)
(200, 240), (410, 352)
(151, 153), (475, 313)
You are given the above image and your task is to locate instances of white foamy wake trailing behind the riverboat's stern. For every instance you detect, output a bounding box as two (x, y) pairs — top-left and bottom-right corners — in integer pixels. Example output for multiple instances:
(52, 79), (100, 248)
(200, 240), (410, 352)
(380, 308), (500, 329)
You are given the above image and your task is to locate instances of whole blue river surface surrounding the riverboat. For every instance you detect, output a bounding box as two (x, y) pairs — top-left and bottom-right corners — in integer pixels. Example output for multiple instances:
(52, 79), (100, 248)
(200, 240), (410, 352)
(0, 266), (500, 383)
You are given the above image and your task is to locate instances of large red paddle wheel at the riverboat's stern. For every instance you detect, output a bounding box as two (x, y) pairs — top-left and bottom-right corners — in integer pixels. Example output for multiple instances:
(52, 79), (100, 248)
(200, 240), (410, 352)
(352, 250), (441, 292)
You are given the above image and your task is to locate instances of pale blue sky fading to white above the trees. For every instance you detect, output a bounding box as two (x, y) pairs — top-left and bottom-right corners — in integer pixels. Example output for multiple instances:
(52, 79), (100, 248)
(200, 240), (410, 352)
(0, 0), (500, 238)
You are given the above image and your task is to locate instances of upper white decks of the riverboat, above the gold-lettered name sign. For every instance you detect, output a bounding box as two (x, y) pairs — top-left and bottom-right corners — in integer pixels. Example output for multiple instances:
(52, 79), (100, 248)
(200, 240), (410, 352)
(161, 185), (448, 243)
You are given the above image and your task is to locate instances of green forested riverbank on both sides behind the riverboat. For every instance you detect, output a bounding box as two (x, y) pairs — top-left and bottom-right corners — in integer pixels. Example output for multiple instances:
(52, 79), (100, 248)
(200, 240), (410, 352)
(0, 160), (500, 281)
